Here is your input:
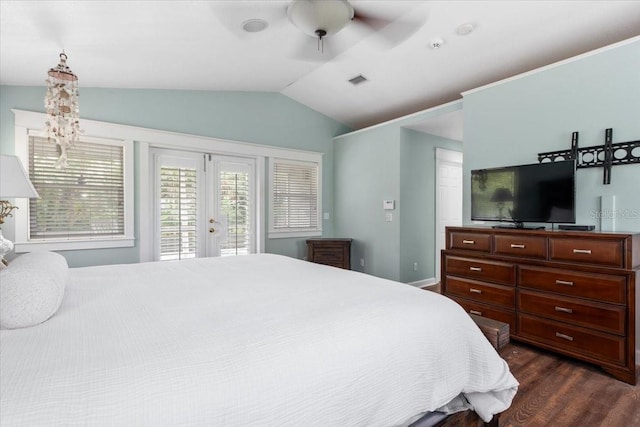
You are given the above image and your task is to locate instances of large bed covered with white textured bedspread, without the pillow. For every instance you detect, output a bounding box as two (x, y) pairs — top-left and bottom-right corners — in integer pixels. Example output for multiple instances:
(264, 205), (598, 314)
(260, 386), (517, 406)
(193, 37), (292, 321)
(0, 253), (518, 427)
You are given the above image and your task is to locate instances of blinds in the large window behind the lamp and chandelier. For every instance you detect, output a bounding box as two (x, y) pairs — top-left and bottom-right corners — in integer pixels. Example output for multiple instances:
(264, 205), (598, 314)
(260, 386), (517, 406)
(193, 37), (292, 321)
(29, 135), (125, 241)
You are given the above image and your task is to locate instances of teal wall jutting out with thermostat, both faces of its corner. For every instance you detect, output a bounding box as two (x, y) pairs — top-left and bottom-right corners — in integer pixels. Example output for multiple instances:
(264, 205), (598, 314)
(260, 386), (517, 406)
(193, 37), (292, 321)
(334, 102), (462, 282)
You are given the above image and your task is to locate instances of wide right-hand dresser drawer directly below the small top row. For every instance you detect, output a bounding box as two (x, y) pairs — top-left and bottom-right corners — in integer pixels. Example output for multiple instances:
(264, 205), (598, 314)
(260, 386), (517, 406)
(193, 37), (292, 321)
(518, 265), (627, 304)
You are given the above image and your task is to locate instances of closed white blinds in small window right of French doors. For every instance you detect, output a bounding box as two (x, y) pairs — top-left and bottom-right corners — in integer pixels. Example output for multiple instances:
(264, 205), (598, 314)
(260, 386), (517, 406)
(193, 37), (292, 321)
(270, 159), (321, 237)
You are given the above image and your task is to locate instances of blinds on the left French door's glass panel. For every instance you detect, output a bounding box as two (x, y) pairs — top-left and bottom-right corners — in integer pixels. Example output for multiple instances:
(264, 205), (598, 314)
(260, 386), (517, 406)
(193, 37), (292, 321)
(160, 166), (198, 261)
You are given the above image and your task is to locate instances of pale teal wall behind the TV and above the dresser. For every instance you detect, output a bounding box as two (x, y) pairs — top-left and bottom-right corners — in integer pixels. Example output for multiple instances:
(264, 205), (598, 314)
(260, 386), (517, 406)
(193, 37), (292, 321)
(463, 38), (640, 231)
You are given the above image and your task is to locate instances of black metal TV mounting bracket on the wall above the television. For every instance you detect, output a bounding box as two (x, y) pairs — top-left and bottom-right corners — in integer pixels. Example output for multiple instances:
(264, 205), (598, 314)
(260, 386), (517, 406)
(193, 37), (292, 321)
(538, 128), (640, 184)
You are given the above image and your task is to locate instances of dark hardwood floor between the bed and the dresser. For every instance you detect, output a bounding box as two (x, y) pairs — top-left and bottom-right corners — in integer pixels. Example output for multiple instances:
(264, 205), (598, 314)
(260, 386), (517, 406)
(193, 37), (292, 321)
(440, 341), (640, 427)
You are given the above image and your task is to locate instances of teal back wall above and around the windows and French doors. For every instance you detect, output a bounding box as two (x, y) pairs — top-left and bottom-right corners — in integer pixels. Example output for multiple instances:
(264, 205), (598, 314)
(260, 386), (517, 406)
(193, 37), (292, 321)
(0, 86), (351, 267)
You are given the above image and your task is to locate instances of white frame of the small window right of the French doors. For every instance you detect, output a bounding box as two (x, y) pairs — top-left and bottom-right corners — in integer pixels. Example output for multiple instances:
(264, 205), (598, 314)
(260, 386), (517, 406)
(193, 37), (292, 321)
(268, 157), (323, 239)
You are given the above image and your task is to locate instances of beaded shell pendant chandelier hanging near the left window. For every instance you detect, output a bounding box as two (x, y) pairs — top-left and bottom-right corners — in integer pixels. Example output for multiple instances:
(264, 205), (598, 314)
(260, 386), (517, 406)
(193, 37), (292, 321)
(44, 52), (81, 168)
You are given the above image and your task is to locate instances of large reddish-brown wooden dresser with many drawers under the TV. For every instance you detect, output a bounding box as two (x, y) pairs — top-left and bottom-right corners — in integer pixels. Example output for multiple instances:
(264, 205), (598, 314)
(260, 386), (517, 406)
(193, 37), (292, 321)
(441, 227), (640, 384)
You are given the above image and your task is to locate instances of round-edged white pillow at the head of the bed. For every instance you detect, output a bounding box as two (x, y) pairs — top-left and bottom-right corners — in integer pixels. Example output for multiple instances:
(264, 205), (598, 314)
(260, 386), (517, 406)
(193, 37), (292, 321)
(0, 252), (69, 329)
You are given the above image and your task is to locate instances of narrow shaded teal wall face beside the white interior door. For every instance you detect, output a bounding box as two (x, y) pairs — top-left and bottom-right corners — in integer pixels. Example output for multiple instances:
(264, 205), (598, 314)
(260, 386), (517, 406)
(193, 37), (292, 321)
(399, 129), (462, 283)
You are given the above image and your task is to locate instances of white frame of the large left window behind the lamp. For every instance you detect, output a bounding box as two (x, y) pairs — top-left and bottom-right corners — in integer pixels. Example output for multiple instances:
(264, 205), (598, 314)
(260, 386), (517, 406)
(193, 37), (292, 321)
(14, 113), (135, 253)
